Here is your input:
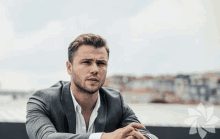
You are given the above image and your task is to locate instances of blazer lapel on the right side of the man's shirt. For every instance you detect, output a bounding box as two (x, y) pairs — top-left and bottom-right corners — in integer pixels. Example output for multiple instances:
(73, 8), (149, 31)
(95, 88), (107, 132)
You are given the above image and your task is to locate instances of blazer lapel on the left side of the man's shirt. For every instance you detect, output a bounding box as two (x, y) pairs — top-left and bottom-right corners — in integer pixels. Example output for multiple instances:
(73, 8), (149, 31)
(61, 82), (76, 134)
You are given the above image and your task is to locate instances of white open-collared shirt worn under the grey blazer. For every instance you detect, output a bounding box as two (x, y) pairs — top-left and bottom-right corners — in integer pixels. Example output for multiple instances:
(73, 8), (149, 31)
(70, 86), (103, 139)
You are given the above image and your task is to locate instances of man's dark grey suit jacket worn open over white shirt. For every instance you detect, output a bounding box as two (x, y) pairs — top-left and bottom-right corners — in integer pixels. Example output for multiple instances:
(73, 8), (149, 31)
(26, 81), (150, 139)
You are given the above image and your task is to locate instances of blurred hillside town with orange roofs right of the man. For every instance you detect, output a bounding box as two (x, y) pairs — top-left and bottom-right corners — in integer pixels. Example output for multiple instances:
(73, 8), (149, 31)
(104, 73), (220, 105)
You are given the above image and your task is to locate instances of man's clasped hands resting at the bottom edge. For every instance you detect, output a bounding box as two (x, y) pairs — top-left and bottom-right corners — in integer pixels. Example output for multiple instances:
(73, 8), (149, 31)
(101, 123), (148, 139)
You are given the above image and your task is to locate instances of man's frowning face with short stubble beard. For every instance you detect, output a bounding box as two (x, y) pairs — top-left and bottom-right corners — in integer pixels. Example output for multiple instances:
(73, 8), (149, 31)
(67, 45), (108, 94)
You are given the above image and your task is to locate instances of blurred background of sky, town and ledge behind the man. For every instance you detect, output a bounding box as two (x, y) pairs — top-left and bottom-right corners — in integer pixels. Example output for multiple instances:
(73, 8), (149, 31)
(0, 0), (220, 139)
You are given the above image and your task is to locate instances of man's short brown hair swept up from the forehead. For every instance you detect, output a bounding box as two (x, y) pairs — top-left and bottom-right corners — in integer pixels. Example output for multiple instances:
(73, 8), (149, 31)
(68, 33), (109, 63)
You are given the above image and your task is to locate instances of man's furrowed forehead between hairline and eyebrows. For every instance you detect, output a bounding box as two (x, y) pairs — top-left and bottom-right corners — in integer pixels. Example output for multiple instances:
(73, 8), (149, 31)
(74, 45), (108, 60)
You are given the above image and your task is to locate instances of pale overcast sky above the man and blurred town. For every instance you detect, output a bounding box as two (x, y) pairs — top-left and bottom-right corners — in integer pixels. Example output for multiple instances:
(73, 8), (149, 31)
(0, 0), (220, 90)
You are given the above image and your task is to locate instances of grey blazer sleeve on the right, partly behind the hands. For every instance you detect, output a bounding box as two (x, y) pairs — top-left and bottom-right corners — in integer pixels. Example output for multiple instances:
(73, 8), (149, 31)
(119, 94), (158, 139)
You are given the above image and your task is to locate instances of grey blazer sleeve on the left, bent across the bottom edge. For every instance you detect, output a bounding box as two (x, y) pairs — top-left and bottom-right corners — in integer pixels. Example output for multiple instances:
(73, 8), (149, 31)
(26, 91), (91, 139)
